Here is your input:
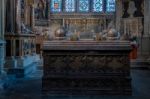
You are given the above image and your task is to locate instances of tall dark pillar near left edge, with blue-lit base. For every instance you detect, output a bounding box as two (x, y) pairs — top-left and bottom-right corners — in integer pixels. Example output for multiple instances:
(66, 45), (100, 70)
(4, 0), (19, 70)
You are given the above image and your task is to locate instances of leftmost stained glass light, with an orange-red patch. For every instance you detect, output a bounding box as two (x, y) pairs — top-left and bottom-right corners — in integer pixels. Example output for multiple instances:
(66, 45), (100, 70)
(51, 0), (62, 12)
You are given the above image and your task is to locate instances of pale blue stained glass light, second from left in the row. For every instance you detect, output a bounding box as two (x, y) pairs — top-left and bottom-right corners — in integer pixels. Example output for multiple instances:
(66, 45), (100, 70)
(65, 0), (75, 12)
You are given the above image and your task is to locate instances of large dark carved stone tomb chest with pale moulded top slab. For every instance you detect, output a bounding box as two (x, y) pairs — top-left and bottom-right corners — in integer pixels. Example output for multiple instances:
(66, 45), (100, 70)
(42, 40), (132, 95)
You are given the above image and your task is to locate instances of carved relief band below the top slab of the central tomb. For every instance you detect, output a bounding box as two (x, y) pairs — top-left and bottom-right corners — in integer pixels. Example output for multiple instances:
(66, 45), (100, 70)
(44, 55), (129, 73)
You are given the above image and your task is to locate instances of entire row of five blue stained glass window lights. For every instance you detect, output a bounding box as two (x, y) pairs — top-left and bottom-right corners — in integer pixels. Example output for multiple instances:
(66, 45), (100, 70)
(50, 0), (116, 12)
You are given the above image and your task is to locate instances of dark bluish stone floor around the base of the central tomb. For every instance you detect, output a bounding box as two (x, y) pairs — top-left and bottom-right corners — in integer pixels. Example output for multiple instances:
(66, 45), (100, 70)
(0, 69), (150, 99)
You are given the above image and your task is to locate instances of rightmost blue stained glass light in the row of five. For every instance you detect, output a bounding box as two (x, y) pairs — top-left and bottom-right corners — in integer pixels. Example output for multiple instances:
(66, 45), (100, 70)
(106, 0), (116, 12)
